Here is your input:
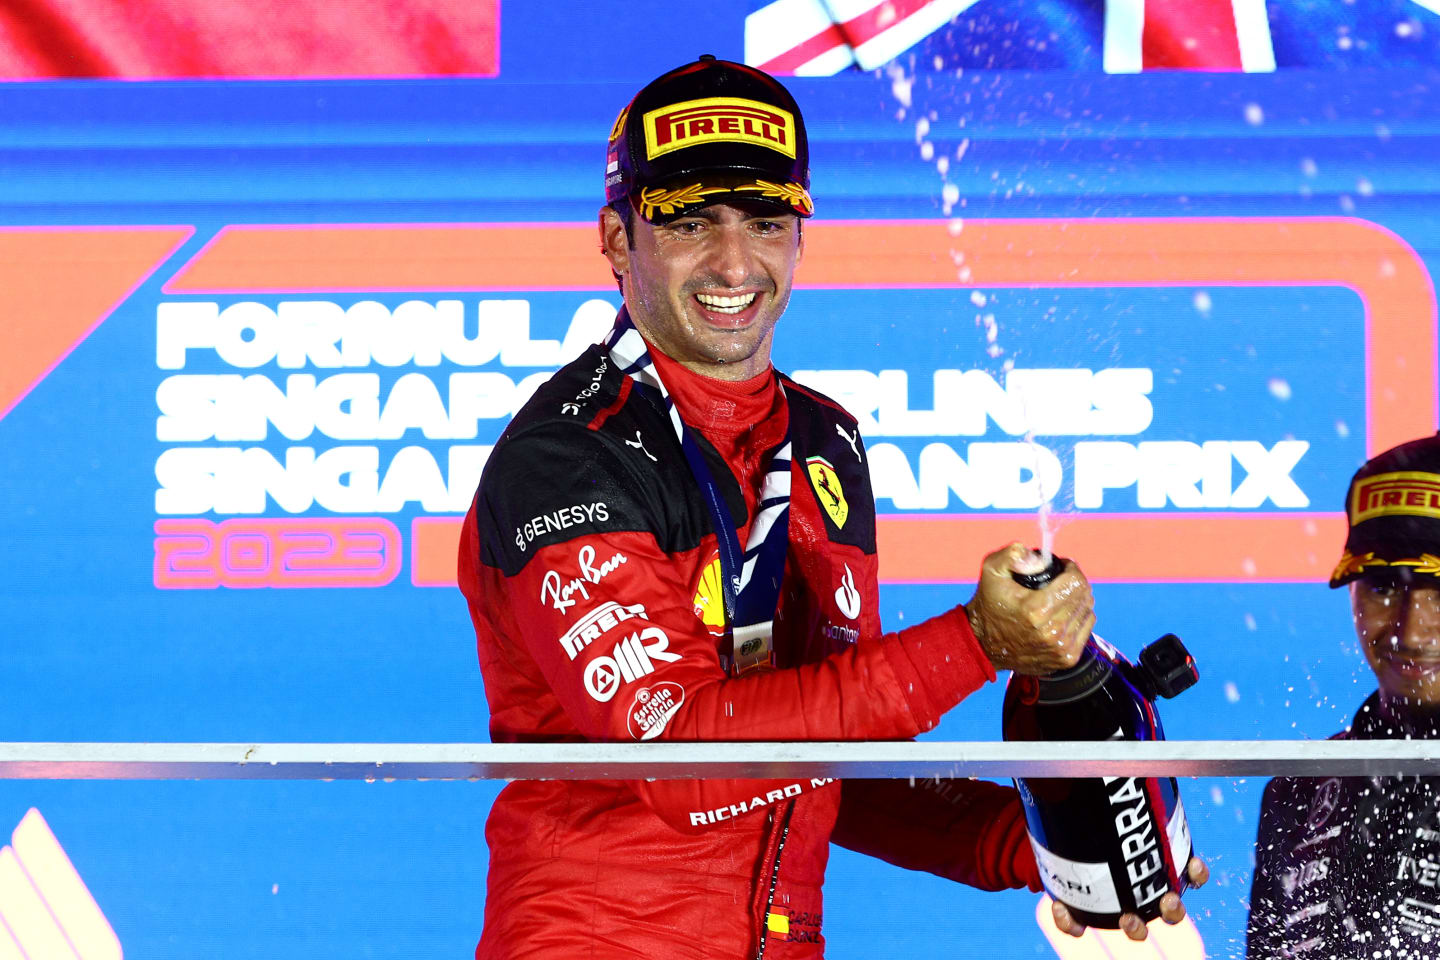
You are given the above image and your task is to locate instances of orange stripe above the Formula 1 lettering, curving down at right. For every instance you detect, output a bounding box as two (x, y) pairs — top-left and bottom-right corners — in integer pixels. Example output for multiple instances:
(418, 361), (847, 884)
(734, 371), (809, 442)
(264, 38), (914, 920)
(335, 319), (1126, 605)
(166, 217), (1437, 453)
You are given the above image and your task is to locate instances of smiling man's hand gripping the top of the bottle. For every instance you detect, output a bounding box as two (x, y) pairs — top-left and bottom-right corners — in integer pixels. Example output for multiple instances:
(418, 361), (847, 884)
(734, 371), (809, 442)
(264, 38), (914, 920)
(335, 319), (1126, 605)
(965, 543), (1094, 676)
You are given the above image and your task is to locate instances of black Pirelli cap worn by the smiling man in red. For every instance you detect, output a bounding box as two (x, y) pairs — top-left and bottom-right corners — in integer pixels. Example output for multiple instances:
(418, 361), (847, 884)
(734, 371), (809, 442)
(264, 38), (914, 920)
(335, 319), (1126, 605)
(605, 55), (815, 223)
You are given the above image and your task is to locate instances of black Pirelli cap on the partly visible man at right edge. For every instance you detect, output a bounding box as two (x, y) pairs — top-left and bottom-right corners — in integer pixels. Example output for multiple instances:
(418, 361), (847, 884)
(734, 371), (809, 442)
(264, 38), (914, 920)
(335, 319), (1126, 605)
(1331, 433), (1440, 587)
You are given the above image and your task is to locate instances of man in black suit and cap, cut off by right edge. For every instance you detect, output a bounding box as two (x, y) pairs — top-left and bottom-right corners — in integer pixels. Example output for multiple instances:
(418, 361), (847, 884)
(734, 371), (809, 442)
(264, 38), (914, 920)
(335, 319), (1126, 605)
(1246, 436), (1440, 960)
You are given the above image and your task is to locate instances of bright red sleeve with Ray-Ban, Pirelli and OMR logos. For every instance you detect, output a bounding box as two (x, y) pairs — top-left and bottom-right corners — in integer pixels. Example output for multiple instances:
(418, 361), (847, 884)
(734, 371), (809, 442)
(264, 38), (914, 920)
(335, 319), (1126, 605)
(485, 521), (995, 829)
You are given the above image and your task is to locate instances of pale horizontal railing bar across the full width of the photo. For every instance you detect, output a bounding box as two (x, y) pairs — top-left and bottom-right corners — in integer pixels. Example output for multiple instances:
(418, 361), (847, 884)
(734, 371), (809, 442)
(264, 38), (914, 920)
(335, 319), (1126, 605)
(0, 740), (1440, 780)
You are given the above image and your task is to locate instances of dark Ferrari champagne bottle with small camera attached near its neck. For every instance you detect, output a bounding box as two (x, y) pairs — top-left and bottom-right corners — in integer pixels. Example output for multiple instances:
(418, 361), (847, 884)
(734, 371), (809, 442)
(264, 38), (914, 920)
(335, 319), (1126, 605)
(1002, 557), (1198, 930)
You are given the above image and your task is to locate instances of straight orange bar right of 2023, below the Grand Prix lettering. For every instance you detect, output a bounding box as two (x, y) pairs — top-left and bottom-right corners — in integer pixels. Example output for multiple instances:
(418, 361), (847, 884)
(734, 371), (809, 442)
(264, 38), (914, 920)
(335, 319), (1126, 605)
(410, 514), (1346, 587)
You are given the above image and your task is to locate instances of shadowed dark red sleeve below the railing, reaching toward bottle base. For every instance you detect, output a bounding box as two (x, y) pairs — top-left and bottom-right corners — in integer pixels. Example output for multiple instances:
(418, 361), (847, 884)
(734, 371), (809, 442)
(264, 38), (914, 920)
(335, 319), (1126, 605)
(831, 780), (1041, 892)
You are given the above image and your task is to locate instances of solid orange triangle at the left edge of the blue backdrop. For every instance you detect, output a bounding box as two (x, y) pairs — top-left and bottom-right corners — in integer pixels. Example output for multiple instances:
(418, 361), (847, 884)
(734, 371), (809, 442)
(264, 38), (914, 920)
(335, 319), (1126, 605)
(0, 226), (194, 419)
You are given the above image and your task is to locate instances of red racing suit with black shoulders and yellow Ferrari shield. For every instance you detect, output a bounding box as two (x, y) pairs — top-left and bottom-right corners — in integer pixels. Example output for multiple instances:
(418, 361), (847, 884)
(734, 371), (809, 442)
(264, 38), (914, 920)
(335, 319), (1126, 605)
(459, 333), (1040, 960)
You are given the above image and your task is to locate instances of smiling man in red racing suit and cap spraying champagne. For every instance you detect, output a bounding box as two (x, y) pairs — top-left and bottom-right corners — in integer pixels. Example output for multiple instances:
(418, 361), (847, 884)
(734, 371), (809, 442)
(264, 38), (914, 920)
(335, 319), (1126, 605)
(459, 56), (1182, 960)
